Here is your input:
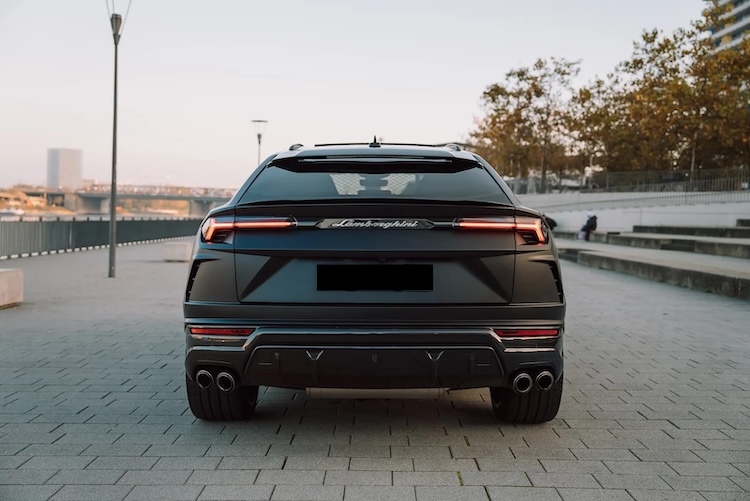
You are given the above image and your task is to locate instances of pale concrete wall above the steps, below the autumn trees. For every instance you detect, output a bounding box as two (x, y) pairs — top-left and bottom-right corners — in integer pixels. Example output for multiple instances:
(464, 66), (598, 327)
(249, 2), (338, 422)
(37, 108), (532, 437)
(518, 193), (750, 231)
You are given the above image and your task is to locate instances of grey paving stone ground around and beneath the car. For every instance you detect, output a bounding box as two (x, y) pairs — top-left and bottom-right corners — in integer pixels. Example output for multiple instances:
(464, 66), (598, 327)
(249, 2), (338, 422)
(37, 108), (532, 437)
(0, 240), (750, 501)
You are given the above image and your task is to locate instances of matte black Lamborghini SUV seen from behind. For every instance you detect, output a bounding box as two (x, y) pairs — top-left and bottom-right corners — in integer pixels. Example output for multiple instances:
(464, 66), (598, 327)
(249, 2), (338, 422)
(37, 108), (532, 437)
(184, 142), (565, 423)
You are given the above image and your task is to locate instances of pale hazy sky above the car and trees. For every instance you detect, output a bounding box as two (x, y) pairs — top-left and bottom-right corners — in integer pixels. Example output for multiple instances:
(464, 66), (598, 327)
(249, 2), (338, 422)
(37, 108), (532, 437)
(0, 0), (704, 188)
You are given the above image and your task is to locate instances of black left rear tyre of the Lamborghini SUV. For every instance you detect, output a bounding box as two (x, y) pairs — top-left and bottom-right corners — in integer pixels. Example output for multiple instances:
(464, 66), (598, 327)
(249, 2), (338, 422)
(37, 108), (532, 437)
(185, 374), (258, 421)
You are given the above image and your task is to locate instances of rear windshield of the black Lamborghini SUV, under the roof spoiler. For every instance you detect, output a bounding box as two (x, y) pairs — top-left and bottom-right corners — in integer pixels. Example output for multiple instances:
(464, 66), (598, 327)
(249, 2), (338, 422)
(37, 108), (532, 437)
(240, 157), (511, 205)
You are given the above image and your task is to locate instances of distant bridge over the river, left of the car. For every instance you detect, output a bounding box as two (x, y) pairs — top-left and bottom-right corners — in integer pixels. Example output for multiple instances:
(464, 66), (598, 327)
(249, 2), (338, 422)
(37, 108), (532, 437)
(23, 184), (234, 216)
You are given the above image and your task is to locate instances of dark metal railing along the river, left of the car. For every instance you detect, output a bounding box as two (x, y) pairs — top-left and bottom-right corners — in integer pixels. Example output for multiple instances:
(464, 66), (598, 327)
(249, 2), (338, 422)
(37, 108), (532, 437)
(0, 217), (201, 258)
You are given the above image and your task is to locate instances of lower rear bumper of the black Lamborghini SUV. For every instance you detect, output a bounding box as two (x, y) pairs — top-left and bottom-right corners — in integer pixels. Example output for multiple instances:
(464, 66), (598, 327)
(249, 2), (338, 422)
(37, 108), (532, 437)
(185, 319), (563, 388)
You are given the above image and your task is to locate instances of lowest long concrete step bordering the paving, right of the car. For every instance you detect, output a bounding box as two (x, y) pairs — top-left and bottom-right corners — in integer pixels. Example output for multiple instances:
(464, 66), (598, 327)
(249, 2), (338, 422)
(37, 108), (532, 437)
(555, 237), (750, 299)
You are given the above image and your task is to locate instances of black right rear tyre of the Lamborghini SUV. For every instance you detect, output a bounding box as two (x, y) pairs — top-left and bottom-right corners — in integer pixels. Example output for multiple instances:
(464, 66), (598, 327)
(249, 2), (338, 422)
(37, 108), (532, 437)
(490, 376), (563, 424)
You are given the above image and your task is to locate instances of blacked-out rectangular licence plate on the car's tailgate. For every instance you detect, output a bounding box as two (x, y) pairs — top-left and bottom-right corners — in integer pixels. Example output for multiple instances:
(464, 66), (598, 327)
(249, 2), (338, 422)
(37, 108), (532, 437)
(318, 264), (432, 291)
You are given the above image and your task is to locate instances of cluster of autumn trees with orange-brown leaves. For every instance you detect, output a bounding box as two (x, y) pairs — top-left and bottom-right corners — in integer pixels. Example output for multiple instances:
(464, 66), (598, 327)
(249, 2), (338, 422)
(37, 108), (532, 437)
(471, 0), (750, 191)
